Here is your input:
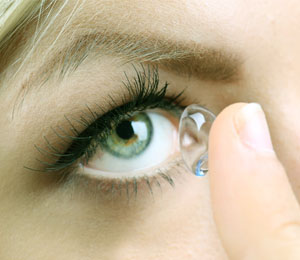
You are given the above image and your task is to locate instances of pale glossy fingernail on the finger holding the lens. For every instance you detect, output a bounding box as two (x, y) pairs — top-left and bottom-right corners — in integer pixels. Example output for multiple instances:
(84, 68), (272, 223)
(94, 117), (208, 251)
(235, 103), (273, 151)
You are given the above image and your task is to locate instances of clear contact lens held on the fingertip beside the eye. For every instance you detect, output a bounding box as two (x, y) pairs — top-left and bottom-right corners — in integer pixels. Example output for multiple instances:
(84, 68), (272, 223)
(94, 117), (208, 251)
(179, 104), (216, 176)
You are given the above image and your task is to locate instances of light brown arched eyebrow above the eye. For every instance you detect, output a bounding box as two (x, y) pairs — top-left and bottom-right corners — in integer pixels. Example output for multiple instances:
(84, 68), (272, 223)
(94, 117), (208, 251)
(23, 32), (242, 86)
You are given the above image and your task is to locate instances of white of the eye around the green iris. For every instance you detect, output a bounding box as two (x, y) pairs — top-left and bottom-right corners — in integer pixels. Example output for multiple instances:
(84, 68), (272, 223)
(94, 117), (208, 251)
(82, 112), (178, 178)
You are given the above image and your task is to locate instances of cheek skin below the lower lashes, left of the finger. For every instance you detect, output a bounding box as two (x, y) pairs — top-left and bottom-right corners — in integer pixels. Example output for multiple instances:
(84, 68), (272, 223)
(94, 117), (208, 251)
(0, 167), (226, 260)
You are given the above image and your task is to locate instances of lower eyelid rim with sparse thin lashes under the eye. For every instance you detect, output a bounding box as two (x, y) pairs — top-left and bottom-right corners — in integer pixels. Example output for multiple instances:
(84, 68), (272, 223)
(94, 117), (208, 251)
(62, 157), (185, 201)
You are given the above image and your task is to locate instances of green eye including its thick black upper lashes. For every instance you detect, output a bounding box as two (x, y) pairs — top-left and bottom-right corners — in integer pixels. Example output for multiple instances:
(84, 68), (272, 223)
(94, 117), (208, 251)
(27, 68), (183, 189)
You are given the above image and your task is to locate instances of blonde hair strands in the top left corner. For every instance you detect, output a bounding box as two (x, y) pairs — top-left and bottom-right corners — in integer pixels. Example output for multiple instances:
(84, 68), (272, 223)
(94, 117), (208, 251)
(0, 0), (68, 84)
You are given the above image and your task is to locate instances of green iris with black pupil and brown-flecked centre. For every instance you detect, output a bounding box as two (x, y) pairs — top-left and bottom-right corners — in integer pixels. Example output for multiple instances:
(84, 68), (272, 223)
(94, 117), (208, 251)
(103, 113), (153, 158)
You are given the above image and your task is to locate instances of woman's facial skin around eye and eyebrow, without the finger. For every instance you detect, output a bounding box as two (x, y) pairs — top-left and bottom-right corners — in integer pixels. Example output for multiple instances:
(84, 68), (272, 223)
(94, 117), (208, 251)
(0, 0), (300, 260)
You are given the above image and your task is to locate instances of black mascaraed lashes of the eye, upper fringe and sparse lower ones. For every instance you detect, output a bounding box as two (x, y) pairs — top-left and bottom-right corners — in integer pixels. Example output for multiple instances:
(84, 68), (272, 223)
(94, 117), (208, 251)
(25, 66), (188, 194)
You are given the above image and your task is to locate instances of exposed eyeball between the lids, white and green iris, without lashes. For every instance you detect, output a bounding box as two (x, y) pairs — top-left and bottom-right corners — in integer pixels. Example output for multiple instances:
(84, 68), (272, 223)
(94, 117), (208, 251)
(82, 109), (178, 178)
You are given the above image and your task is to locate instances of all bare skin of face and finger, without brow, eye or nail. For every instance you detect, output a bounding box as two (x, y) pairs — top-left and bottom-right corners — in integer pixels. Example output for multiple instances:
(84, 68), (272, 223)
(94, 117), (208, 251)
(0, 0), (300, 260)
